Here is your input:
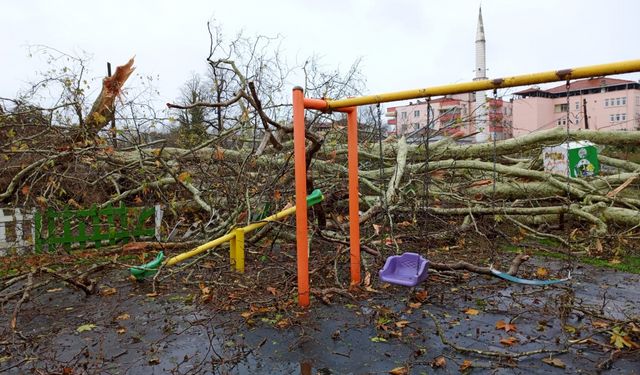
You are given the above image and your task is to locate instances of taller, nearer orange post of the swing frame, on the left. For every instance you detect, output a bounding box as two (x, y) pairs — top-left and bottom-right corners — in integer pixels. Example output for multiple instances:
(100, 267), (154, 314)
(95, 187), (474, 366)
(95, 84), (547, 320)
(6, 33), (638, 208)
(293, 86), (309, 307)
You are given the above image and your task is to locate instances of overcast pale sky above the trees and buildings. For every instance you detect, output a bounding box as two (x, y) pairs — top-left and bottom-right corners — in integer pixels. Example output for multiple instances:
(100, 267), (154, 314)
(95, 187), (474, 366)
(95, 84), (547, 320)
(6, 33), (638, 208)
(0, 0), (640, 108)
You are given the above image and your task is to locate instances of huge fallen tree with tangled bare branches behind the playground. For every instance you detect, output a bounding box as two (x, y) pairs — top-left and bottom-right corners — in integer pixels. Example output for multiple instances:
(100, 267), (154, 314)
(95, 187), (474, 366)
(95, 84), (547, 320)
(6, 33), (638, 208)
(0, 40), (640, 274)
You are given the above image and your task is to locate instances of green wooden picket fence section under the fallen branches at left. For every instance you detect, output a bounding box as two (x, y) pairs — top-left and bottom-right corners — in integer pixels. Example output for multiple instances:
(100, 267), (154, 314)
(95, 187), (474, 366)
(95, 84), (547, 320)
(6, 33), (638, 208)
(34, 202), (162, 253)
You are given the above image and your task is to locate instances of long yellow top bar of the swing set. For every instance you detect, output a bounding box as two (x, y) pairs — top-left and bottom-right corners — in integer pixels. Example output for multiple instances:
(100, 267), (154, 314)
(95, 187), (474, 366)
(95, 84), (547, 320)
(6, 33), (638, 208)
(326, 60), (640, 109)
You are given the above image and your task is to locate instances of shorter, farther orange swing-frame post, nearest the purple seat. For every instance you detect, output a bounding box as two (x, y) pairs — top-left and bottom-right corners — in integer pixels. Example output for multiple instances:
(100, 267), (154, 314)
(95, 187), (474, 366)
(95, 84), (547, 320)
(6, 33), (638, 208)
(347, 107), (360, 285)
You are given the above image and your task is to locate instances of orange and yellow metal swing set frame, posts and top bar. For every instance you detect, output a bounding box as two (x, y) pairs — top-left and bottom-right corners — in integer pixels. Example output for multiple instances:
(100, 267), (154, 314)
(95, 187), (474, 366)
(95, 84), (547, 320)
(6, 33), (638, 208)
(293, 59), (640, 307)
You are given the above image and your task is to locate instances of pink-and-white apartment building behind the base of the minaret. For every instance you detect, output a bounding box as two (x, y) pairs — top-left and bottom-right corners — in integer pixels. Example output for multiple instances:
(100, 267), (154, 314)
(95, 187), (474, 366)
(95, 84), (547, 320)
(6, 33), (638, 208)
(387, 94), (512, 140)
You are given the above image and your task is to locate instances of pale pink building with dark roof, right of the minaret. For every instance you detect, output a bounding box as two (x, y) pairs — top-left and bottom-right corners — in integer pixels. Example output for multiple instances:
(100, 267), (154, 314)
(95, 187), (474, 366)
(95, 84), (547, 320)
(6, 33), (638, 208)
(513, 78), (640, 137)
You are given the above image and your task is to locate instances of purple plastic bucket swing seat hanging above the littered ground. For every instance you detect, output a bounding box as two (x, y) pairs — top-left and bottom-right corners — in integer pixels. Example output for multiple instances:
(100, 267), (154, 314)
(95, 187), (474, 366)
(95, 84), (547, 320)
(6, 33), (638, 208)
(379, 253), (429, 286)
